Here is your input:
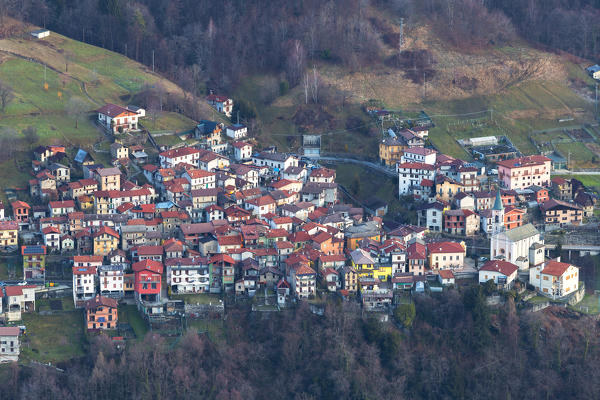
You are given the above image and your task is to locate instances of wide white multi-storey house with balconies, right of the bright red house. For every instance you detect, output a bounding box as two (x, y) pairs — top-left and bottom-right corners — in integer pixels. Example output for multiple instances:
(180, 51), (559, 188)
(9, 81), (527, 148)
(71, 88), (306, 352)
(165, 257), (210, 293)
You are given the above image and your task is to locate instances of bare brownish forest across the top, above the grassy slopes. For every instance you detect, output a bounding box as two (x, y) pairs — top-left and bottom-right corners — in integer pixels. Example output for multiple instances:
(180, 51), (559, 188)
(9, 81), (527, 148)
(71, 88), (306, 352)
(0, 0), (600, 94)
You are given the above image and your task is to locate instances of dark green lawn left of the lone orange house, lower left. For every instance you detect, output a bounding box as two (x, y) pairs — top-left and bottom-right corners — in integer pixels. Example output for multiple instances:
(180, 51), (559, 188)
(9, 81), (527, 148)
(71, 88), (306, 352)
(19, 310), (87, 363)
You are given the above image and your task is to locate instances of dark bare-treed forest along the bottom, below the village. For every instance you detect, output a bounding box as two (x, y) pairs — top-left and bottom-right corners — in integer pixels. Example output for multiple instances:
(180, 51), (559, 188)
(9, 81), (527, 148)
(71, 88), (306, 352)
(0, 286), (600, 400)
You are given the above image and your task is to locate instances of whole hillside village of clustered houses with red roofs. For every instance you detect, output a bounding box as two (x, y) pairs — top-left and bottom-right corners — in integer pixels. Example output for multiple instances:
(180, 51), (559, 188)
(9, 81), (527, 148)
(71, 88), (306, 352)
(0, 79), (596, 361)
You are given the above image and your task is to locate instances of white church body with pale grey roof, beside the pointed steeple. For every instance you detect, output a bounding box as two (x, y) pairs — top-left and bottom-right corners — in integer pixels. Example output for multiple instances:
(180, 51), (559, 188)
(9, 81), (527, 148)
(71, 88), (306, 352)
(490, 224), (544, 269)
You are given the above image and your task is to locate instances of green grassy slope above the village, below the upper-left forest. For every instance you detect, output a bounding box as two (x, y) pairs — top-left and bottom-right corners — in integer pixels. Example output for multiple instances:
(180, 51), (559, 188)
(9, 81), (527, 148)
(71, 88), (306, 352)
(0, 28), (214, 188)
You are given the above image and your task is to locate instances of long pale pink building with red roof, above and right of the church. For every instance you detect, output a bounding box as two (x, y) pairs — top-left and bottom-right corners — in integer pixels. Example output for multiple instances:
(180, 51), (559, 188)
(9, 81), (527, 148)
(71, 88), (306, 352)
(497, 155), (552, 189)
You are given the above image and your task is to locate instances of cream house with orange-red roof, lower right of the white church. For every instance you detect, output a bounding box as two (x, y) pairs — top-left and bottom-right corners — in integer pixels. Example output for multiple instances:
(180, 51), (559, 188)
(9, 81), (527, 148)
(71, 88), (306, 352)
(529, 260), (579, 299)
